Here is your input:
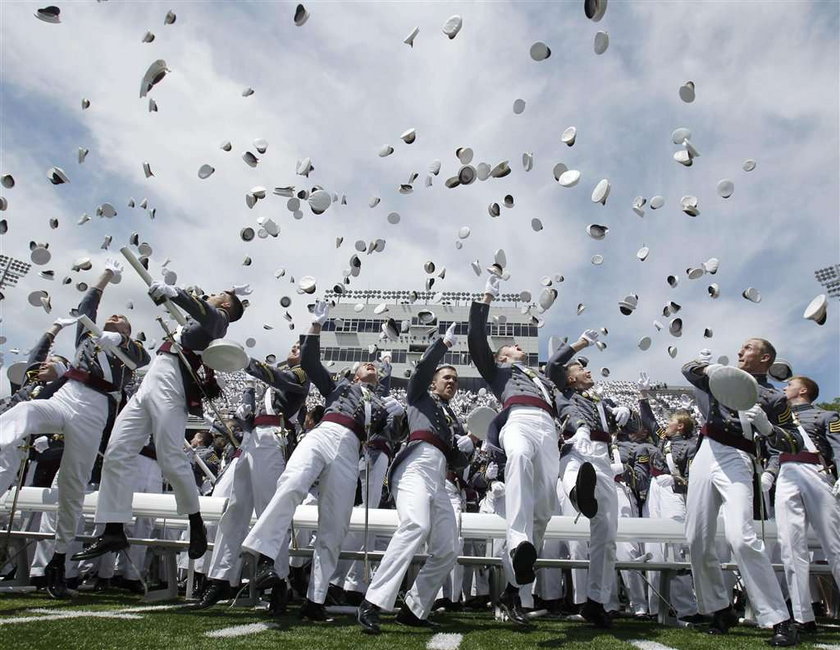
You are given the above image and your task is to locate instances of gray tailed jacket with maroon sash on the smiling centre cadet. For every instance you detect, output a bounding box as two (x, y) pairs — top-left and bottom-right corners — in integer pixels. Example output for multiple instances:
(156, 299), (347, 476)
(388, 339), (469, 476)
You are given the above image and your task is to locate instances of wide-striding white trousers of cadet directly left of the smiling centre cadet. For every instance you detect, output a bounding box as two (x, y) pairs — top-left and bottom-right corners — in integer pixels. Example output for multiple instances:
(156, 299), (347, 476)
(242, 422), (359, 604)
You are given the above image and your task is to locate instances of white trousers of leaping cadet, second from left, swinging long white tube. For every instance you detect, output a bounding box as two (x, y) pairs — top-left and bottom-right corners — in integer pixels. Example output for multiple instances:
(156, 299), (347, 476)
(95, 354), (199, 523)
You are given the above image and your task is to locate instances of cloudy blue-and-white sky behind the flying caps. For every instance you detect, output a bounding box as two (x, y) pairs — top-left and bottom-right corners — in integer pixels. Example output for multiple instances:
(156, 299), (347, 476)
(0, 0), (840, 400)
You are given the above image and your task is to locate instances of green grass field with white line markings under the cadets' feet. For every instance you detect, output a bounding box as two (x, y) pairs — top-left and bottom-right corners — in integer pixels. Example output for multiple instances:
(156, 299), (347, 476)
(0, 593), (840, 650)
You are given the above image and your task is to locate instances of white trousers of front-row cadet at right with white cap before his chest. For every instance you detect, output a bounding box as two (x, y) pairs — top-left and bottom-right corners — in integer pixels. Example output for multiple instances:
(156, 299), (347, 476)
(685, 438), (789, 627)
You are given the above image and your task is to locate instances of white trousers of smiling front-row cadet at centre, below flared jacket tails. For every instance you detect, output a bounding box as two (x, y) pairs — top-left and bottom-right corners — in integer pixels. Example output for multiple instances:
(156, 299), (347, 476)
(365, 442), (458, 619)
